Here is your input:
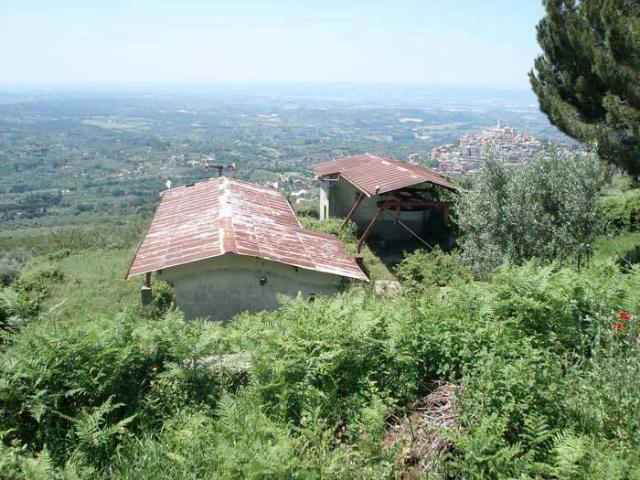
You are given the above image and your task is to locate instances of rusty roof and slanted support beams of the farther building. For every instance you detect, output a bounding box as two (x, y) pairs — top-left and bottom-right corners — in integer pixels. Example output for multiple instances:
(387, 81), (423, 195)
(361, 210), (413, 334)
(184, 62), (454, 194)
(313, 153), (457, 254)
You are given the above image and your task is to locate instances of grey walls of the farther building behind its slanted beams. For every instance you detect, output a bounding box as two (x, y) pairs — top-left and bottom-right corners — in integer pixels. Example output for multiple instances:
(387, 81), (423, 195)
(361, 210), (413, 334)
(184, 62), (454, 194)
(320, 178), (430, 240)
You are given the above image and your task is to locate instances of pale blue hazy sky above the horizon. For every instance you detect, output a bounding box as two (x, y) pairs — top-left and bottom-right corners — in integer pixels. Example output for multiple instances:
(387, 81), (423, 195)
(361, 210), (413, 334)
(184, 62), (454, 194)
(0, 0), (544, 88)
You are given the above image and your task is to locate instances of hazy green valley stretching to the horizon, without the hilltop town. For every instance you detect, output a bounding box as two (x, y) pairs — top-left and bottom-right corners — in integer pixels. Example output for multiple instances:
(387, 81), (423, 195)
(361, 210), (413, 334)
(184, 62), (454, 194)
(0, 86), (566, 230)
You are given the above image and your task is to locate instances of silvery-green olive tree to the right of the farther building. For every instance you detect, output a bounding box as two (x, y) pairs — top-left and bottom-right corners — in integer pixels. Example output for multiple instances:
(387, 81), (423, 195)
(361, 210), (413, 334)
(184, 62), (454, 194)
(458, 152), (602, 275)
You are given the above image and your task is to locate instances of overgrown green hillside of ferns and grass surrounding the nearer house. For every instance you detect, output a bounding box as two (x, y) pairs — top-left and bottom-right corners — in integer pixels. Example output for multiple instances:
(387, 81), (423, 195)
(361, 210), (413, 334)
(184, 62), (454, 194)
(0, 178), (640, 479)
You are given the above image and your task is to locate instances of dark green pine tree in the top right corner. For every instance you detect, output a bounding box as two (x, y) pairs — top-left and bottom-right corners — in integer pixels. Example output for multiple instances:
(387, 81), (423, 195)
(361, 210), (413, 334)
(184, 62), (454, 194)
(529, 0), (640, 177)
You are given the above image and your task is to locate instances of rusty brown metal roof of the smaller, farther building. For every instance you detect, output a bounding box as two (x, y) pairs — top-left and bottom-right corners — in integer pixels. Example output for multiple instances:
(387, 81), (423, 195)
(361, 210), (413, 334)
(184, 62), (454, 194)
(313, 153), (458, 197)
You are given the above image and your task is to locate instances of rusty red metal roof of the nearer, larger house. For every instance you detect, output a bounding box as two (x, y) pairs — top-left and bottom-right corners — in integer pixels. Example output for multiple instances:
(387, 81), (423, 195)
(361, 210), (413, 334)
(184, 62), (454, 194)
(127, 177), (367, 280)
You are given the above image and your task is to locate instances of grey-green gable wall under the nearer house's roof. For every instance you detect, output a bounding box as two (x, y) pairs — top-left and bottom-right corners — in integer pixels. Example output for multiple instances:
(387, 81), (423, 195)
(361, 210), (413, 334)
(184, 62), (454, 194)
(158, 254), (340, 322)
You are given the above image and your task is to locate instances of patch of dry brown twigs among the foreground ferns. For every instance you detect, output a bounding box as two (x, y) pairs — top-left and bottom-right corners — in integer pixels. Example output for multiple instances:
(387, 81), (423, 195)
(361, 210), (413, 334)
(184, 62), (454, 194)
(384, 383), (460, 479)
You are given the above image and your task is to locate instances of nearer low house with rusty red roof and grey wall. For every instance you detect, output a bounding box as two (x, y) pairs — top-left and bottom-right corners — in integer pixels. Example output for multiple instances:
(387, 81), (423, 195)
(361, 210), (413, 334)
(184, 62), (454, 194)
(127, 177), (367, 321)
